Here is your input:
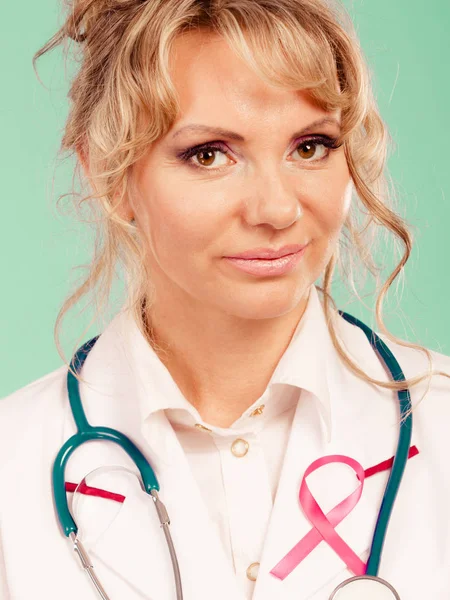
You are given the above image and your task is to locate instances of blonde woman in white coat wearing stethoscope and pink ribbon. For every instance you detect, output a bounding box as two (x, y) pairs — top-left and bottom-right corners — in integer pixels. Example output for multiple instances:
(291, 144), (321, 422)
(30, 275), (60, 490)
(0, 0), (450, 600)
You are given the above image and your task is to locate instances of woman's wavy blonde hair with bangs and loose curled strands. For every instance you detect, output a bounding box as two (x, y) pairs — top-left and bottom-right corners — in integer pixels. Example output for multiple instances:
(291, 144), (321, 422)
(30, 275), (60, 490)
(33, 0), (450, 398)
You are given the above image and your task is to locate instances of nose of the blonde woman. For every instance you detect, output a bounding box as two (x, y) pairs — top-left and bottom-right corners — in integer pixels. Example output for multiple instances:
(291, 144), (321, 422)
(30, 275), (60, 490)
(244, 172), (303, 229)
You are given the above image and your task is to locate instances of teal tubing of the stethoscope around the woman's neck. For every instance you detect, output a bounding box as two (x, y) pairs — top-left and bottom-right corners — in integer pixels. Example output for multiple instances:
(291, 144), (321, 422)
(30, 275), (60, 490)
(52, 311), (412, 577)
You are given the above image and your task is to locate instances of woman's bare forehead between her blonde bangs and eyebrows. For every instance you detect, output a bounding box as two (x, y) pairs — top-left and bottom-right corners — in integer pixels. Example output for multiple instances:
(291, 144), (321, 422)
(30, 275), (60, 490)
(171, 31), (338, 128)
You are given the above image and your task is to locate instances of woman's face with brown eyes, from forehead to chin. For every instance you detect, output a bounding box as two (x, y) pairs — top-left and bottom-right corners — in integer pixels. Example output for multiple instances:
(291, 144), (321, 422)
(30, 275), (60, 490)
(128, 32), (352, 319)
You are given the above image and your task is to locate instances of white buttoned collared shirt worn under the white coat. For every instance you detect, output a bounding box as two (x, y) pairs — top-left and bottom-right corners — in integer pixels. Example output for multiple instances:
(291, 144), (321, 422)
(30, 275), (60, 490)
(132, 286), (330, 600)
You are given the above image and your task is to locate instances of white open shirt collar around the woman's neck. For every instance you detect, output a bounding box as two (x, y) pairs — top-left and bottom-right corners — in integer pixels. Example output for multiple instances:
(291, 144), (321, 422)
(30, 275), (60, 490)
(110, 285), (332, 439)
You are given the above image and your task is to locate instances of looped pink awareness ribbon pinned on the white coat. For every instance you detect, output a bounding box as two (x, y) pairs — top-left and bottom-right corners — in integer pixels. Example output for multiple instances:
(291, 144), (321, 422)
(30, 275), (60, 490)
(270, 454), (366, 580)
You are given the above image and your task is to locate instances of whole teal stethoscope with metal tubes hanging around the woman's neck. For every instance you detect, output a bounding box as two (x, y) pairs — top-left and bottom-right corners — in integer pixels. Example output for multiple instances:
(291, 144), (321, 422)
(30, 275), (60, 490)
(52, 311), (412, 600)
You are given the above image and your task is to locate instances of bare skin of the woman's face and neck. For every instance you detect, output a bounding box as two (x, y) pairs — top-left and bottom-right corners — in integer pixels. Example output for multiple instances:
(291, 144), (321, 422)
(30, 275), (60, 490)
(81, 32), (352, 427)
